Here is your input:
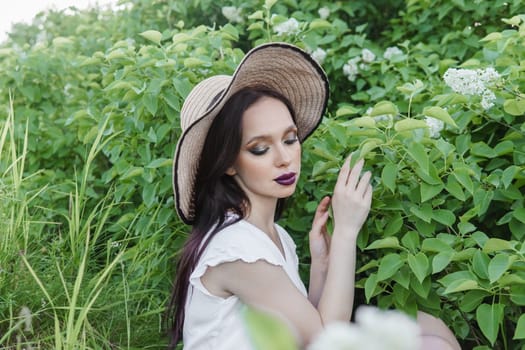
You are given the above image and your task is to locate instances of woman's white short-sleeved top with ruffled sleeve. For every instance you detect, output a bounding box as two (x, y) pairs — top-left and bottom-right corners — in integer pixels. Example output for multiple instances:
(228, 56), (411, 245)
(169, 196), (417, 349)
(183, 220), (307, 350)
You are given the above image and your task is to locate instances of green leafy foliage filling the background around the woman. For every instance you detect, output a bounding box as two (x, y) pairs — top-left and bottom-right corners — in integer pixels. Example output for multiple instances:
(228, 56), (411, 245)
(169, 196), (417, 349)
(0, 0), (525, 349)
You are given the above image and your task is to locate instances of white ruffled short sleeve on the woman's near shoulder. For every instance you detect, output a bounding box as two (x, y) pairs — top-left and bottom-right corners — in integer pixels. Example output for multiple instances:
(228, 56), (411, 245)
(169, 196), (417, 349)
(190, 220), (285, 297)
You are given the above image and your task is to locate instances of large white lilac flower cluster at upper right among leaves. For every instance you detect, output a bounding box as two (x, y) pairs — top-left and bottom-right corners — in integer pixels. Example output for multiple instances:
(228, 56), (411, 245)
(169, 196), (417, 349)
(443, 67), (501, 109)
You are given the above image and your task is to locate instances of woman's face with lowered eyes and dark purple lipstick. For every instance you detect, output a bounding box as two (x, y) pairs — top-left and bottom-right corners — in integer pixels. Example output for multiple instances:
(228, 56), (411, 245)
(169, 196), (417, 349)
(227, 97), (301, 205)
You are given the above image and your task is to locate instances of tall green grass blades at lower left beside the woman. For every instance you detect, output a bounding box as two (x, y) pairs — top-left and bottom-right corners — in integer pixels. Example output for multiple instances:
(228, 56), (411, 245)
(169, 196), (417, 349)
(0, 98), (175, 350)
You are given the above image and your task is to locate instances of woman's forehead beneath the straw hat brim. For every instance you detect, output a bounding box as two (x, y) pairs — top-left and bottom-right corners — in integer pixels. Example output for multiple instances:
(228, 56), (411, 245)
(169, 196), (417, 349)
(242, 97), (295, 139)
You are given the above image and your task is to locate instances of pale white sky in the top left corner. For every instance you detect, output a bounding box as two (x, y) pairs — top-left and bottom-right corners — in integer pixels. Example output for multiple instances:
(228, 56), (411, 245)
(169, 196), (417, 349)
(0, 0), (117, 42)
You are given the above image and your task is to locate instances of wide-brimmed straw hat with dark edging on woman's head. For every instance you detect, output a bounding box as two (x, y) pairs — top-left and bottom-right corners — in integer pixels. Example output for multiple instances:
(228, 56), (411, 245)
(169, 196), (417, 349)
(173, 43), (329, 224)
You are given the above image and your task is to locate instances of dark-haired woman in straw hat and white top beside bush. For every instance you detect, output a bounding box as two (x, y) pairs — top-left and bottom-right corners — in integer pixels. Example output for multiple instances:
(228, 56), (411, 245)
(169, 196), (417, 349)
(171, 43), (458, 349)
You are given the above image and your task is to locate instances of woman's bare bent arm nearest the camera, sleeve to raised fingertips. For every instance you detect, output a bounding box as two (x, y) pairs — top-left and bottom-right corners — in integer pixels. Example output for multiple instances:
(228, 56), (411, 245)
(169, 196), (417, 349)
(202, 160), (372, 345)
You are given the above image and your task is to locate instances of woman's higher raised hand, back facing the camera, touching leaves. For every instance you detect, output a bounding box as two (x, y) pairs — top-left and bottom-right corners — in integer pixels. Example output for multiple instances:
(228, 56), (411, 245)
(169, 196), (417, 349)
(332, 155), (372, 238)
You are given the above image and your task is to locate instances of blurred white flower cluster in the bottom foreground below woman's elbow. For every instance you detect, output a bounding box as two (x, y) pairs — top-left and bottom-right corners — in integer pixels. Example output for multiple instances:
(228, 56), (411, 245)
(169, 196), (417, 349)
(308, 306), (421, 350)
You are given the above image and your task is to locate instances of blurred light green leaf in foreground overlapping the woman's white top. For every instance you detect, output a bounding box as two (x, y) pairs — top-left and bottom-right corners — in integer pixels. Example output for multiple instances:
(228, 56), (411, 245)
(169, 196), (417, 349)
(242, 306), (298, 350)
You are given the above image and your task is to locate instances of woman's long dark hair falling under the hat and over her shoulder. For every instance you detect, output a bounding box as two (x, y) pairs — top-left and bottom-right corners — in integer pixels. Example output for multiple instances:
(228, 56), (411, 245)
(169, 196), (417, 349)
(168, 88), (295, 349)
